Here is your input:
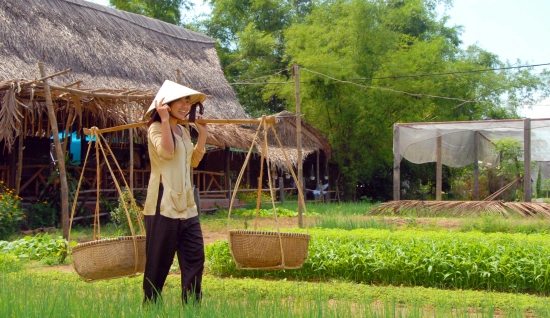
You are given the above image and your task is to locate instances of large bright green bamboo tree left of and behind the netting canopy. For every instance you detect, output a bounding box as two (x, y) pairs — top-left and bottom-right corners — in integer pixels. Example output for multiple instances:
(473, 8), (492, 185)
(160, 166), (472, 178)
(263, 0), (548, 199)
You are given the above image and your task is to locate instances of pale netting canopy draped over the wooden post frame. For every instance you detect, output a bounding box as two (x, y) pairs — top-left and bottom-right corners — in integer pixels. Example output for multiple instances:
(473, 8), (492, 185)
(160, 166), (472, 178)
(394, 119), (550, 175)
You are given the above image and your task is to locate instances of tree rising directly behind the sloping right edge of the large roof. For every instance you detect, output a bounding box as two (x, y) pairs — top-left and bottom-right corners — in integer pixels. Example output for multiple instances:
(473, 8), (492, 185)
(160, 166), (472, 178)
(195, 0), (312, 117)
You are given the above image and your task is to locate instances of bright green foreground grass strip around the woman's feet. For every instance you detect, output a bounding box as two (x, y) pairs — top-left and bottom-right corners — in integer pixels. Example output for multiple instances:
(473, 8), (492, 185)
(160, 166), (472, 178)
(0, 271), (550, 318)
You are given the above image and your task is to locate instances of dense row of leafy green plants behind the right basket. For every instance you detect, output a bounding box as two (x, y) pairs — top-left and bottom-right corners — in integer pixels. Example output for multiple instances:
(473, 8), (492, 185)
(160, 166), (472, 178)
(207, 229), (550, 294)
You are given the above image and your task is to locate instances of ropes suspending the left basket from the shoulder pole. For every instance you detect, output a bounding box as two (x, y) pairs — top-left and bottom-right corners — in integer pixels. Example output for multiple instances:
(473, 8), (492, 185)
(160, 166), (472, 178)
(67, 127), (145, 278)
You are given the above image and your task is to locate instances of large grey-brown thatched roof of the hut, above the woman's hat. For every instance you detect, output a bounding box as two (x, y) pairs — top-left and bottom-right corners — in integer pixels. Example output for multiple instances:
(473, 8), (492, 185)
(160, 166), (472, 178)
(0, 0), (246, 146)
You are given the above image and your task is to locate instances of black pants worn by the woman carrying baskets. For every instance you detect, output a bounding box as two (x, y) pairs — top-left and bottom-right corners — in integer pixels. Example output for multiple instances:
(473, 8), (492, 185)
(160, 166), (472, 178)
(143, 184), (204, 303)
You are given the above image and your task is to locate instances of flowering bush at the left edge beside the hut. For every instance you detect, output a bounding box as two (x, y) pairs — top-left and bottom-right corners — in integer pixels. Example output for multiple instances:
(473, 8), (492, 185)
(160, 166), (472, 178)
(0, 181), (26, 240)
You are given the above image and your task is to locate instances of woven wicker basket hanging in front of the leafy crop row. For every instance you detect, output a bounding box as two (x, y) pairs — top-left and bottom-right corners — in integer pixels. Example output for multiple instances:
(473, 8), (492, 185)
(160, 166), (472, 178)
(229, 230), (310, 269)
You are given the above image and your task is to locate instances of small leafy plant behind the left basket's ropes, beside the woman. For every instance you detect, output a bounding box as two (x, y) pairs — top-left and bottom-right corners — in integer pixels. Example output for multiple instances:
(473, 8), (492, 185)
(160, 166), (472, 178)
(111, 190), (143, 236)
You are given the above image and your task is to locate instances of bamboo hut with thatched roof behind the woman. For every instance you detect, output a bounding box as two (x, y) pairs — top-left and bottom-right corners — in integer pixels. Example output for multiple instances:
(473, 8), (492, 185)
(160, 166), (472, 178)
(0, 0), (330, 219)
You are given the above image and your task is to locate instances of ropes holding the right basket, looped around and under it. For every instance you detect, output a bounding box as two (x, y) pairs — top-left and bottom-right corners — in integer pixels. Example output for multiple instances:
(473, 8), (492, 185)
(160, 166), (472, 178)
(227, 115), (309, 269)
